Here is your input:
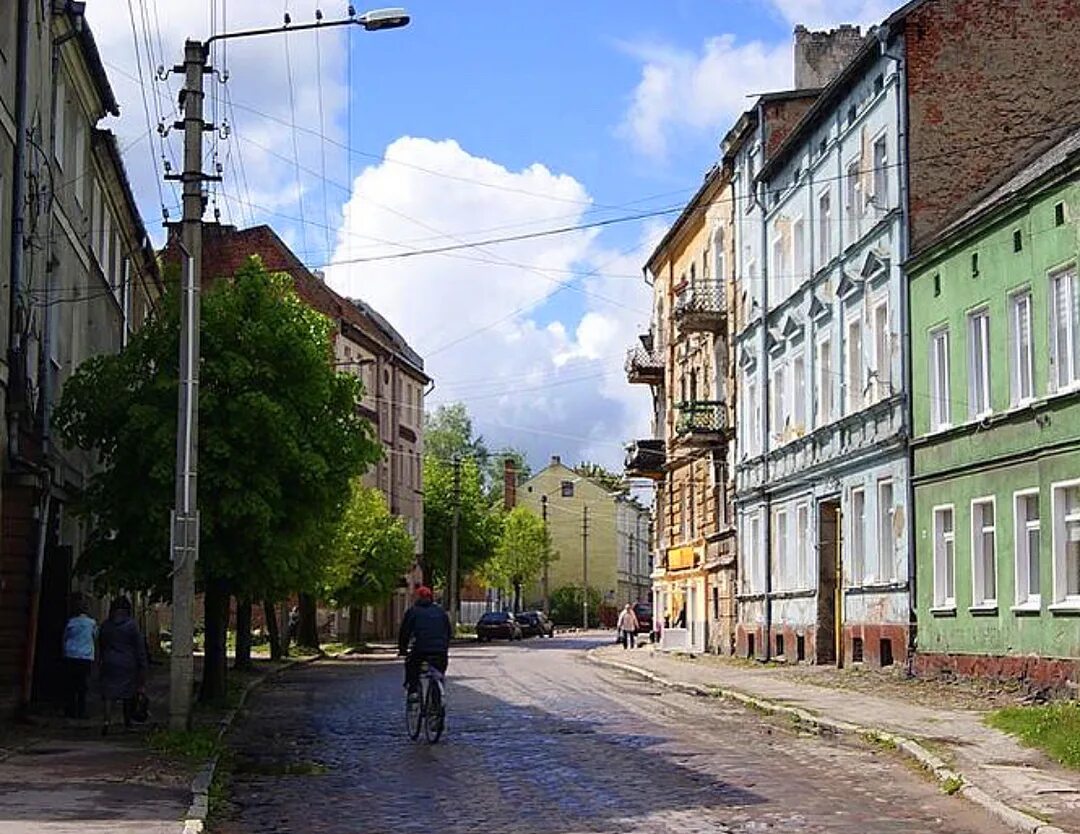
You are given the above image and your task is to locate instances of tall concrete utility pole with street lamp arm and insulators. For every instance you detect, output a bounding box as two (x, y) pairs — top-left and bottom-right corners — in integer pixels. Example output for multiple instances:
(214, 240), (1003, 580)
(165, 6), (409, 729)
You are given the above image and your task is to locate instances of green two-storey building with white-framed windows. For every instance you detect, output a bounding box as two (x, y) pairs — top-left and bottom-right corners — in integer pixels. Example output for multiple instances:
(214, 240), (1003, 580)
(907, 133), (1080, 687)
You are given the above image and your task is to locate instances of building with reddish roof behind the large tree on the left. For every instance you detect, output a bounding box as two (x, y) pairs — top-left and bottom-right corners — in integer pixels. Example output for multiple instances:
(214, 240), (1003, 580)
(163, 224), (431, 637)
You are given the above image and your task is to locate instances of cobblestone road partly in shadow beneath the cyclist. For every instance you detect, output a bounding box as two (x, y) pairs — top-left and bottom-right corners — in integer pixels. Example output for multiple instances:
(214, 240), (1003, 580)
(212, 637), (1004, 834)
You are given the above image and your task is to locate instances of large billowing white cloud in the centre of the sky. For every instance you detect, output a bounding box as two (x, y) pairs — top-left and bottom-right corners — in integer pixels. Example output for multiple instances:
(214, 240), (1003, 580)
(327, 137), (651, 468)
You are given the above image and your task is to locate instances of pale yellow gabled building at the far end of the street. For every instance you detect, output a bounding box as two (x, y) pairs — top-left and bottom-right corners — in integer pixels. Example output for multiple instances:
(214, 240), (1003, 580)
(517, 456), (650, 609)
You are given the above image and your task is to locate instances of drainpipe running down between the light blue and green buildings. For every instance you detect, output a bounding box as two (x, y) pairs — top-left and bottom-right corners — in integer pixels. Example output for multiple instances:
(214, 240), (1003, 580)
(878, 27), (918, 673)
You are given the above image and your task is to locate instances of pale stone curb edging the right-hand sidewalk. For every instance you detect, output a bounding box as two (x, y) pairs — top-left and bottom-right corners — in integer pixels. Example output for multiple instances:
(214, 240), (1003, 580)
(585, 649), (1068, 834)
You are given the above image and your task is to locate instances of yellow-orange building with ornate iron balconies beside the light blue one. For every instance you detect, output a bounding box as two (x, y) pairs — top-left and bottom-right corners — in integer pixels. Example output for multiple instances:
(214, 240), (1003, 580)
(626, 167), (735, 654)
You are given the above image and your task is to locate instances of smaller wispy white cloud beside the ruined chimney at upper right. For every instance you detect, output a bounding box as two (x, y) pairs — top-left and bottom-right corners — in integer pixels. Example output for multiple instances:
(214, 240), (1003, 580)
(619, 35), (792, 158)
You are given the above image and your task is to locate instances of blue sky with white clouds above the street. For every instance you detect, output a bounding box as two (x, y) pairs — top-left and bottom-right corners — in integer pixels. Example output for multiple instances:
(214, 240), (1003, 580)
(86, 0), (892, 479)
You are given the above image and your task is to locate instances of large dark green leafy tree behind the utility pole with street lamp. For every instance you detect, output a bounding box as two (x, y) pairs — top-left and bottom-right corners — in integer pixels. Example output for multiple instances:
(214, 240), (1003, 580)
(56, 258), (381, 700)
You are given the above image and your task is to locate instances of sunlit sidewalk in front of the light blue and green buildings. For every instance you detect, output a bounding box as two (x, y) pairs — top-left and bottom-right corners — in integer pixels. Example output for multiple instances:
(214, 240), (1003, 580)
(590, 647), (1080, 834)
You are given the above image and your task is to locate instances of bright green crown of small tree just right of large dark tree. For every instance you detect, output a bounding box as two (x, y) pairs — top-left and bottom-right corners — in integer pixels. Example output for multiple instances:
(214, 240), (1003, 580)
(322, 481), (415, 607)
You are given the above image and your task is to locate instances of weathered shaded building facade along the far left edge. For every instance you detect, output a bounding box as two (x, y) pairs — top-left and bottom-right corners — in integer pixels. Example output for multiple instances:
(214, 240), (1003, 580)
(0, 3), (162, 704)
